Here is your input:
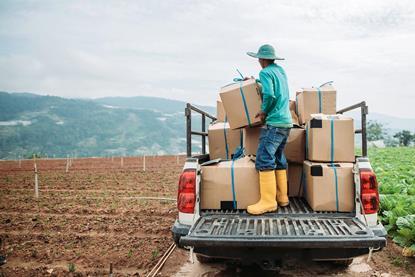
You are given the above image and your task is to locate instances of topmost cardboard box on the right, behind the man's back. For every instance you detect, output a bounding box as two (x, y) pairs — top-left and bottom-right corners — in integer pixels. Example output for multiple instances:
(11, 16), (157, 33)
(296, 84), (337, 125)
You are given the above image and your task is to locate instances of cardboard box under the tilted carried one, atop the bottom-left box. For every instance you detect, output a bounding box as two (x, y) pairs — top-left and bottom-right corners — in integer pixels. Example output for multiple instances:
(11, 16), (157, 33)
(208, 122), (243, 160)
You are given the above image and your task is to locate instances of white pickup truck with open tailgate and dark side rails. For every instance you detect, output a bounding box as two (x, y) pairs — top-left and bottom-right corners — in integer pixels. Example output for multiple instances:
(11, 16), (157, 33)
(172, 102), (386, 269)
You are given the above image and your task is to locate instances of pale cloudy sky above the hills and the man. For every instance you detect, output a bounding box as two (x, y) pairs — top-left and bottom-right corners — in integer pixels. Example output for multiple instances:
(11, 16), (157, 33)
(0, 0), (415, 118)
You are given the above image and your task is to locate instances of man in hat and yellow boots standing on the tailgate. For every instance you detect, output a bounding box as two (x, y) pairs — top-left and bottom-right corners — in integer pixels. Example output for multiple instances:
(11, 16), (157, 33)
(247, 44), (292, 215)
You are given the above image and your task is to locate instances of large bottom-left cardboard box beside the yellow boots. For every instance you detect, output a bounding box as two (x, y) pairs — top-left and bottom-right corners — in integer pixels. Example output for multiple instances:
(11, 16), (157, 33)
(200, 157), (260, 210)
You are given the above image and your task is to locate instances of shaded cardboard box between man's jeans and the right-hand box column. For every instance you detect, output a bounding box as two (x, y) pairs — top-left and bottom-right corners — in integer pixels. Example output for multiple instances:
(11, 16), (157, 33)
(284, 128), (306, 164)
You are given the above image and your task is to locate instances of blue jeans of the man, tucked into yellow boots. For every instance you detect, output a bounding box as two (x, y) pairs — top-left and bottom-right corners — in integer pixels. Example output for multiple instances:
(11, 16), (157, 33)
(255, 125), (291, 171)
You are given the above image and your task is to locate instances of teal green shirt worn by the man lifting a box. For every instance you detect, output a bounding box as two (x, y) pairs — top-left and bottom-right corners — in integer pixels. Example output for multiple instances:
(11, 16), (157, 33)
(259, 63), (293, 128)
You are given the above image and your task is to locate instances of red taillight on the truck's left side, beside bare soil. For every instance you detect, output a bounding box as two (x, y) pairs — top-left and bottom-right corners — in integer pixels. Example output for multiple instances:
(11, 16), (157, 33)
(177, 169), (196, 214)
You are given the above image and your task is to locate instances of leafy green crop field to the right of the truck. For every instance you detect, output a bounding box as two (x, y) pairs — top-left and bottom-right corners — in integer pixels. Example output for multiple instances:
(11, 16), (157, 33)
(369, 147), (415, 251)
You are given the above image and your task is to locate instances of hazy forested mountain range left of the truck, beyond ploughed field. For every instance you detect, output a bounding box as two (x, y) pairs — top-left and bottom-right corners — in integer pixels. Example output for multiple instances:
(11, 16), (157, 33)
(0, 92), (214, 159)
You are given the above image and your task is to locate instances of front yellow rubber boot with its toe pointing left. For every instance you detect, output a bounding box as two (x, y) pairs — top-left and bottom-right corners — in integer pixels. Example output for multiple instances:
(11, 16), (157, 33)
(247, 170), (278, 215)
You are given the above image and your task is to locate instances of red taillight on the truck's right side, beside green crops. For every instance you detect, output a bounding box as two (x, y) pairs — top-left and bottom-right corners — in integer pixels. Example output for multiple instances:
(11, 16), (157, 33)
(360, 169), (379, 214)
